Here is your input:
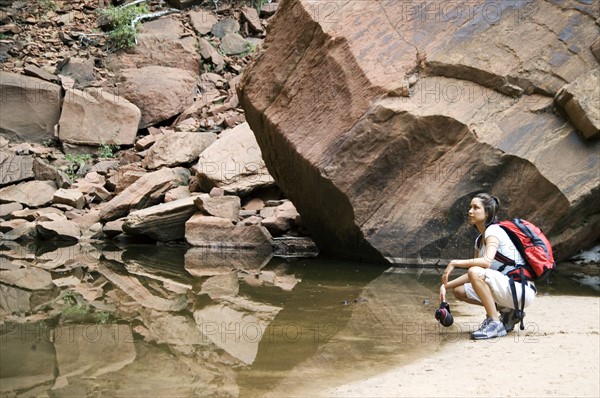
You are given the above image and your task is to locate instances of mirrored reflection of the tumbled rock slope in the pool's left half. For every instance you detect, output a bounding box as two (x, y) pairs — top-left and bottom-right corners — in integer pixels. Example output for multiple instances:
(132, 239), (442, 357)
(0, 242), (299, 396)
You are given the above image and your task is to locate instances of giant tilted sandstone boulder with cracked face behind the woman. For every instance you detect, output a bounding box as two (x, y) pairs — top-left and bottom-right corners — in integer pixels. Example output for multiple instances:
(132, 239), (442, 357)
(239, 0), (600, 263)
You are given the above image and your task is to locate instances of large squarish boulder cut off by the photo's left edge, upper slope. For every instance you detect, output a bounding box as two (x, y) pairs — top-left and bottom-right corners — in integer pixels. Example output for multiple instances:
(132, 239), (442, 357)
(0, 71), (61, 143)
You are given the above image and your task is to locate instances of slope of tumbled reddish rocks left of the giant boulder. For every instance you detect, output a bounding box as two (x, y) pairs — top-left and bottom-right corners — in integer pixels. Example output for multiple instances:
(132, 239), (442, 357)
(0, 0), (316, 253)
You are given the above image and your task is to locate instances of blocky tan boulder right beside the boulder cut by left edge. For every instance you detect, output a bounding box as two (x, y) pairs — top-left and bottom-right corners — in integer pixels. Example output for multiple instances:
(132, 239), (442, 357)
(59, 88), (142, 145)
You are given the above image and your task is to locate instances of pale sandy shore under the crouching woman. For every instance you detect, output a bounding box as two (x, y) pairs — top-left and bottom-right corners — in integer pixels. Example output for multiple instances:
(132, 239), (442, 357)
(319, 296), (600, 397)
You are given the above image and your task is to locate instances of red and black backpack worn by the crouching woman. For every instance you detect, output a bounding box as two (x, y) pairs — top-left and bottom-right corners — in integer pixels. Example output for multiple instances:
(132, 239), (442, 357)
(495, 218), (556, 281)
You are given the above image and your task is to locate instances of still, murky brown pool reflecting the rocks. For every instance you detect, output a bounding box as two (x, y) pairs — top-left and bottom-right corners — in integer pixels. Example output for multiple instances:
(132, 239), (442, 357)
(0, 242), (598, 397)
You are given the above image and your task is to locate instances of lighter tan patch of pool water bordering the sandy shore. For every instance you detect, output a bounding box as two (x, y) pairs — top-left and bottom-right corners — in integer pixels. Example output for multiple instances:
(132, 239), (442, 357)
(251, 273), (442, 397)
